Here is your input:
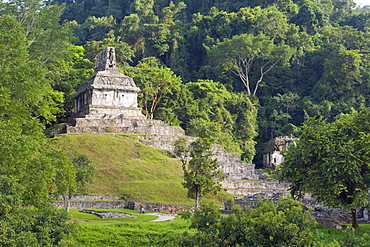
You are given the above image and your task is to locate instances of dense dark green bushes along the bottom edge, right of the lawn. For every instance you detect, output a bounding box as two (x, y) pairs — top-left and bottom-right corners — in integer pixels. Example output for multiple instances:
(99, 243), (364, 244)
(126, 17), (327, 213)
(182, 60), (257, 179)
(180, 198), (315, 246)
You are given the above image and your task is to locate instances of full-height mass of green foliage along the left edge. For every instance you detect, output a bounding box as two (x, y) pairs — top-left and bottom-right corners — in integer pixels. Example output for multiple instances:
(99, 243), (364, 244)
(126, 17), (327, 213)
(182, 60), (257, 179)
(0, 5), (87, 246)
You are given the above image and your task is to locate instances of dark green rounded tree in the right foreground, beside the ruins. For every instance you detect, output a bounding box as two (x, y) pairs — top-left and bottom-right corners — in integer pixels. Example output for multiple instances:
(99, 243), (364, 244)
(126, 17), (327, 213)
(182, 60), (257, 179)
(281, 109), (370, 227)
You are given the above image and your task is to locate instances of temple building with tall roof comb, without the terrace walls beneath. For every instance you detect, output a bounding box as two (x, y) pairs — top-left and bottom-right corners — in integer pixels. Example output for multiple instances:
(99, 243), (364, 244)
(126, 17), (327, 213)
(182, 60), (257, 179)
(75, 47), (145, 119)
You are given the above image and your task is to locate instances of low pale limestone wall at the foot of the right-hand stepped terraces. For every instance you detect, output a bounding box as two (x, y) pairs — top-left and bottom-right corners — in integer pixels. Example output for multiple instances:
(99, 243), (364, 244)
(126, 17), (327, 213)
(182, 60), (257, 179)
(222, 179), (290, 195)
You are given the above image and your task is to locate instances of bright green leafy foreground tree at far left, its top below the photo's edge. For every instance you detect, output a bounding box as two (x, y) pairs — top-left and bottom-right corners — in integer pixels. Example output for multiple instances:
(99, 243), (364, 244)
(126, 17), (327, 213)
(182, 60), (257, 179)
(0, 15), (74, 204)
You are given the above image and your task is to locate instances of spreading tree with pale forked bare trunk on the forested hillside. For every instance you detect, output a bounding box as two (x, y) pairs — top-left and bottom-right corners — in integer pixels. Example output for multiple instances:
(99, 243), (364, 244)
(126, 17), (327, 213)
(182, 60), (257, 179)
(208, 34), (294, 96)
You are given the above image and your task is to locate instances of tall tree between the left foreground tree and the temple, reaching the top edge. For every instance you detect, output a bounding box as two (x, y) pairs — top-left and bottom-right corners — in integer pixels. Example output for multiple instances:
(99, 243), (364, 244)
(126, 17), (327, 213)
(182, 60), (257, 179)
(0, 0), (95, 122)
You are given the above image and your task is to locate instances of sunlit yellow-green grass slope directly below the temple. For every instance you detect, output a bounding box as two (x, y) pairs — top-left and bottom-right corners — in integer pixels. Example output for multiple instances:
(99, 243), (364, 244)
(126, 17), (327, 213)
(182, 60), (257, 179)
(55, 134), (232, 204)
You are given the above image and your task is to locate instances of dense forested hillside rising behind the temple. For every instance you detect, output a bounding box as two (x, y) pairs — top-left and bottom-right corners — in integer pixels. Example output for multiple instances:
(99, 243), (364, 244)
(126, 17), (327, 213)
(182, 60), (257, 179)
(35, 0), (370, 165)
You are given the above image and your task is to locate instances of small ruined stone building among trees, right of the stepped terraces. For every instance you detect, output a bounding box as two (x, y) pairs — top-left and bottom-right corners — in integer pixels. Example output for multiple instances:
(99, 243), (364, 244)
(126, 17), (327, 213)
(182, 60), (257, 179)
(263, 135), (297, 167)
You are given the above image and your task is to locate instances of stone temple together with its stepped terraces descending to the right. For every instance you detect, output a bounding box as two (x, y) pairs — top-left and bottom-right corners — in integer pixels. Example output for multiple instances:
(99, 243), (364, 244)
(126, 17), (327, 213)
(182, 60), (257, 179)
(66, 47), (286, 195)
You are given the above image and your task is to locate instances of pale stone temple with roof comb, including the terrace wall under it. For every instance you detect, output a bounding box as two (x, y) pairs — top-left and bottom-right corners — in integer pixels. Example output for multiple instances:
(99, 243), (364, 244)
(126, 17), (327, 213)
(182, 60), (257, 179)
(67, 47), (185, 136)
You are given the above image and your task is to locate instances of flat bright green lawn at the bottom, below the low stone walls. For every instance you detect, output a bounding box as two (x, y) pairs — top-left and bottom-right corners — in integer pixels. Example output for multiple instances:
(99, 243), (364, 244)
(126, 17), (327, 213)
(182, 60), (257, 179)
(69, 209), (189, 247)
